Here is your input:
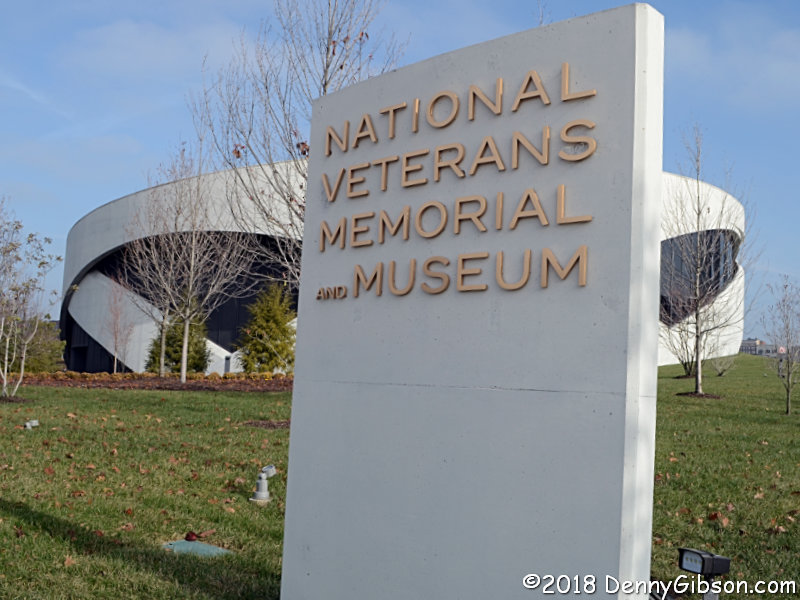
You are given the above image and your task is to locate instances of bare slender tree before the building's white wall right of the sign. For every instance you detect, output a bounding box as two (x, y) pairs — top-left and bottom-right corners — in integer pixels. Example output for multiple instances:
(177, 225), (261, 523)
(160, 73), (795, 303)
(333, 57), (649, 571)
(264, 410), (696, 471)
(661, 126), (746, 394)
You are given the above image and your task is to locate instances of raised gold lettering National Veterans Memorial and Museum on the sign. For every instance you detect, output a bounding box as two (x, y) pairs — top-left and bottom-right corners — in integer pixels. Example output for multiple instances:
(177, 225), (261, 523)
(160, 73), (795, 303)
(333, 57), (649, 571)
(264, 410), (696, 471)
(318, 62), (600, 300)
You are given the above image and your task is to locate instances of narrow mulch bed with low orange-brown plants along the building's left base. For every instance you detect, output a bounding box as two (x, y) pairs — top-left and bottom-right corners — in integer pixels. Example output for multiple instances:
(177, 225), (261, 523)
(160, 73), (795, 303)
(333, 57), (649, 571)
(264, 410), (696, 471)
(23, 375), (294, 392)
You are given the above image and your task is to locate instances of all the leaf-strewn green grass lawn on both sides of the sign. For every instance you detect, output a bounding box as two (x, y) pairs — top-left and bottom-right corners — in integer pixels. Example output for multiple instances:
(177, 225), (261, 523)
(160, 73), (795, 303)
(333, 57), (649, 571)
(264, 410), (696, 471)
(0, 356), (800, 599)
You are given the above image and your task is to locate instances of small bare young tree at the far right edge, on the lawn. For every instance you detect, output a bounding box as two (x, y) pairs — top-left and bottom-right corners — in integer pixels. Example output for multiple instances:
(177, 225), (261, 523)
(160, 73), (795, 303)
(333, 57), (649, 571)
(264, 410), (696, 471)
(761, 276), (800, 415)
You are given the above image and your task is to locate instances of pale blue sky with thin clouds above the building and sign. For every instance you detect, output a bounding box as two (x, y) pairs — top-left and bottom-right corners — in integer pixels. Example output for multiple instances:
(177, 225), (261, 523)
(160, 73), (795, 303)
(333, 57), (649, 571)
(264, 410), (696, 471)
(0, 0), (800, 333)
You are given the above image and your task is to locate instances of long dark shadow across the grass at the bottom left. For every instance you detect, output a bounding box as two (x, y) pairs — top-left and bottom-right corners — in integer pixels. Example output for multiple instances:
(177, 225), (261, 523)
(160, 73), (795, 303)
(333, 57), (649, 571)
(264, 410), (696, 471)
(0, 498), (280, 600)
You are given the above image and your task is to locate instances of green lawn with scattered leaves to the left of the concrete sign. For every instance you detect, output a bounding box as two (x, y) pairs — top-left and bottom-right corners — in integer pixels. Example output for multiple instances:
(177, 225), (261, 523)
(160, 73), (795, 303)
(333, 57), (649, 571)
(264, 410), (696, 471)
(0, 387), (290, 599)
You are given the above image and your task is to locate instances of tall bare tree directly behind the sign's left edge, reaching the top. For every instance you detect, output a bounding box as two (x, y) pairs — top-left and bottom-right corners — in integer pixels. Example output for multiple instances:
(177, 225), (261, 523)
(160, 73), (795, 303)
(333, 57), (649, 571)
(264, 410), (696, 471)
(192, 0), (400, 289)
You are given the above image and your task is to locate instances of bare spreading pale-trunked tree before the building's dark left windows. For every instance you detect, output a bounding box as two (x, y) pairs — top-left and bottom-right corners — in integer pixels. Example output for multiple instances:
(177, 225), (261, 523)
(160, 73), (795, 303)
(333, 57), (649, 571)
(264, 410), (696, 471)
(124, 145), (255, 382)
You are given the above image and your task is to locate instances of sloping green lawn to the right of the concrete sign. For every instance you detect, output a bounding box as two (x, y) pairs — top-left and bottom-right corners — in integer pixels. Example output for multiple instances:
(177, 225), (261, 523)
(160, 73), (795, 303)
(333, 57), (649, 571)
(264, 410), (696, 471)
(653, 355), (800, 598)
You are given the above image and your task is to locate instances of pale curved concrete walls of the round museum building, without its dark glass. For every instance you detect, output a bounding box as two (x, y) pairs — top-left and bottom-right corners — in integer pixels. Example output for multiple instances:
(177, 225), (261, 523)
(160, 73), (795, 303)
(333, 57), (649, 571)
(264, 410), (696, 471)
(61, 163), (745, 373)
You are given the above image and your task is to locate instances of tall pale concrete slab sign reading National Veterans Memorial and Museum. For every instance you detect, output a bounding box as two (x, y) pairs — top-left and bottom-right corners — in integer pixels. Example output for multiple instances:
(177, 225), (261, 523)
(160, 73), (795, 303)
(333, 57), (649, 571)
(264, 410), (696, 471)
(282, 4), (663, 600)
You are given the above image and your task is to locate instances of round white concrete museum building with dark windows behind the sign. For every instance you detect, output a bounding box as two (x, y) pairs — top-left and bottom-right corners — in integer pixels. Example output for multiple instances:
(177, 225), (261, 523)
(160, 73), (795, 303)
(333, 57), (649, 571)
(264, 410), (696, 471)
(60, 165), (745, 373)
